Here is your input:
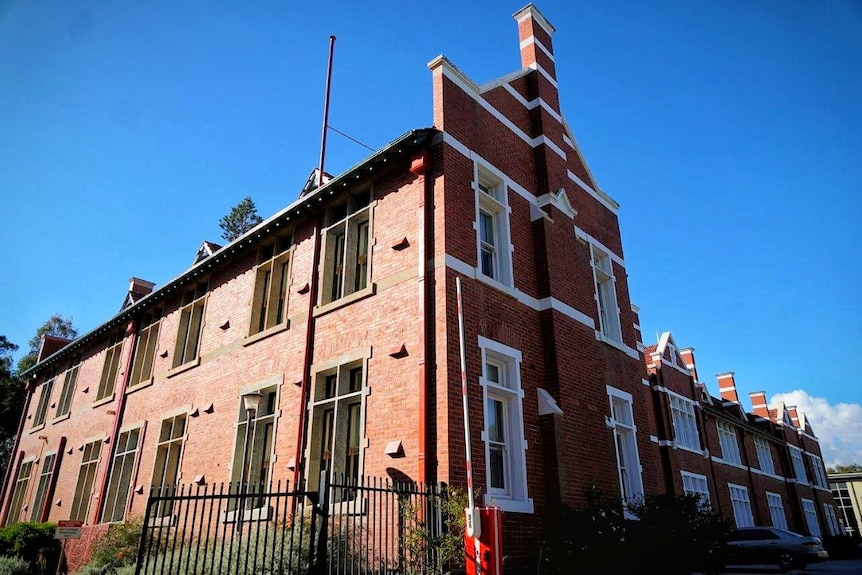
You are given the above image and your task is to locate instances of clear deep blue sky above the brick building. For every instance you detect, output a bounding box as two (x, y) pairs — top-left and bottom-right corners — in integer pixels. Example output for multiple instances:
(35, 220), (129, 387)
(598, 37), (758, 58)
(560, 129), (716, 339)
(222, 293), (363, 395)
(0, 0), (862, 462)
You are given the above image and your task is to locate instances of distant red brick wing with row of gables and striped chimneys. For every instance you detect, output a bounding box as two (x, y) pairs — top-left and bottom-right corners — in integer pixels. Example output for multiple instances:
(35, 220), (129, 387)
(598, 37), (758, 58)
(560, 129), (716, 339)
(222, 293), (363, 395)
(644, 332), (843, 537)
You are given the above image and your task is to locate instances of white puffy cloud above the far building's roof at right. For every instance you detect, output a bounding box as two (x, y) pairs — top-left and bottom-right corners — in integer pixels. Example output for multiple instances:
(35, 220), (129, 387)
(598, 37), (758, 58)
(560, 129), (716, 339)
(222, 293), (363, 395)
(769, 389), (862, 467)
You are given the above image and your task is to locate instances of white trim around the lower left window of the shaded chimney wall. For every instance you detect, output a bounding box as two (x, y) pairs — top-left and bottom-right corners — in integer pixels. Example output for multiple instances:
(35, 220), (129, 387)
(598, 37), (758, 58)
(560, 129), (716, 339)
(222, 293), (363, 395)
(478, 335), (533, 513)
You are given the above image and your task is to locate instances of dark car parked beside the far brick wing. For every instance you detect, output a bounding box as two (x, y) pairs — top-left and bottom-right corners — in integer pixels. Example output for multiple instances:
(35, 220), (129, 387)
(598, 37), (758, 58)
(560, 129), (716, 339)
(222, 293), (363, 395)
(716, 527), (829, 571)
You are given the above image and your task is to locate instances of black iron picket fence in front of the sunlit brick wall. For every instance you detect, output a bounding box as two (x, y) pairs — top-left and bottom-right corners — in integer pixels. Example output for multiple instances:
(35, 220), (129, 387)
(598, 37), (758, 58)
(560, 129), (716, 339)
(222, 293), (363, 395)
(135, 478), (457, 575)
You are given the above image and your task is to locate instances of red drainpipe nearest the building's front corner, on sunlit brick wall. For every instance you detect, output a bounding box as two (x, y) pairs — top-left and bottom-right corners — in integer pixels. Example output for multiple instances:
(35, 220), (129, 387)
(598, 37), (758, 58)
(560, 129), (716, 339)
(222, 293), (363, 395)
(410, 150), (434, 484)
